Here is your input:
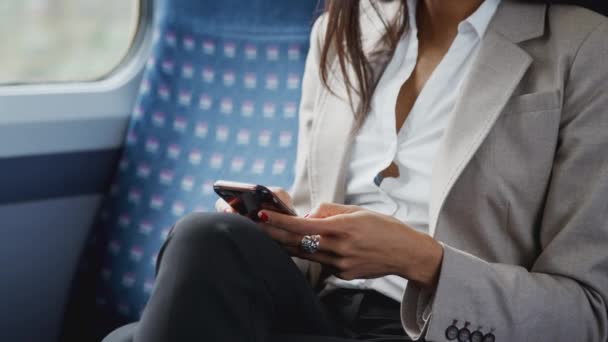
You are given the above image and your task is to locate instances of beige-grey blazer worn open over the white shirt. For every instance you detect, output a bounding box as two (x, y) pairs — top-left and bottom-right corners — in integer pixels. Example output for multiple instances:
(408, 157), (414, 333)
(292, 0), (608, 342)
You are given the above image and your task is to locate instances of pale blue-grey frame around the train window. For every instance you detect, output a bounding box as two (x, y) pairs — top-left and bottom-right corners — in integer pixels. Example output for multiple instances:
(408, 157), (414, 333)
(0, 0), (156, 158)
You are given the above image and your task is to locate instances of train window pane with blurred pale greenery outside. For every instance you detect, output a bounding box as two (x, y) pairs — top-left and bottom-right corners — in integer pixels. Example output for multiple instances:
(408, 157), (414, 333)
(0, 0), (140, 84)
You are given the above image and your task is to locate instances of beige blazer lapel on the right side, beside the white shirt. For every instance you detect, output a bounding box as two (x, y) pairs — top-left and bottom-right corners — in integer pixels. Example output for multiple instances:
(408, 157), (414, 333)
(429, 1), (545, 235)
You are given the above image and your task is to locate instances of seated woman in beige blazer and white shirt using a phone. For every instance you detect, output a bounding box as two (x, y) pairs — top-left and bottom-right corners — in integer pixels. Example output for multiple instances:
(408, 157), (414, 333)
(107, 0), (608, 342)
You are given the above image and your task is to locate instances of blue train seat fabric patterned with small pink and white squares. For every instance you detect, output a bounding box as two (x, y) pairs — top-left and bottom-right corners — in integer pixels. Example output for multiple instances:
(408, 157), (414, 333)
(63, 0), (316, 341)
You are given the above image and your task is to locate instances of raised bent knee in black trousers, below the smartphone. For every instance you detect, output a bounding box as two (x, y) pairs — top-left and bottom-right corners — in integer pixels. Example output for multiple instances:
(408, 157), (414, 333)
(112, 213), (334, 342)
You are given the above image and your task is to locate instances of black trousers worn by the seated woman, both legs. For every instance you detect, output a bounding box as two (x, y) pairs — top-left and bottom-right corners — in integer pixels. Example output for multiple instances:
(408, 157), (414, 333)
(104, 213), (408, 342)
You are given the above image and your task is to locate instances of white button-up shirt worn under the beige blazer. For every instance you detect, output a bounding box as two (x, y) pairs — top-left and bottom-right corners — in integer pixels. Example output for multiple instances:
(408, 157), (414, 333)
(326, 0), (500, 301)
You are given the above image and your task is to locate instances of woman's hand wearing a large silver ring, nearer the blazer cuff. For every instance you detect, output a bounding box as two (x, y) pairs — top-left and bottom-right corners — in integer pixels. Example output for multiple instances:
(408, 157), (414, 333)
(259, 204), (443, 288)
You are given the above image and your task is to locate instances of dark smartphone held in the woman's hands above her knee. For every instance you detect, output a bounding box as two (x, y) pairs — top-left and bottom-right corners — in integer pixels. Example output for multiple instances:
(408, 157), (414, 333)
(213, 180), (297, 221)
